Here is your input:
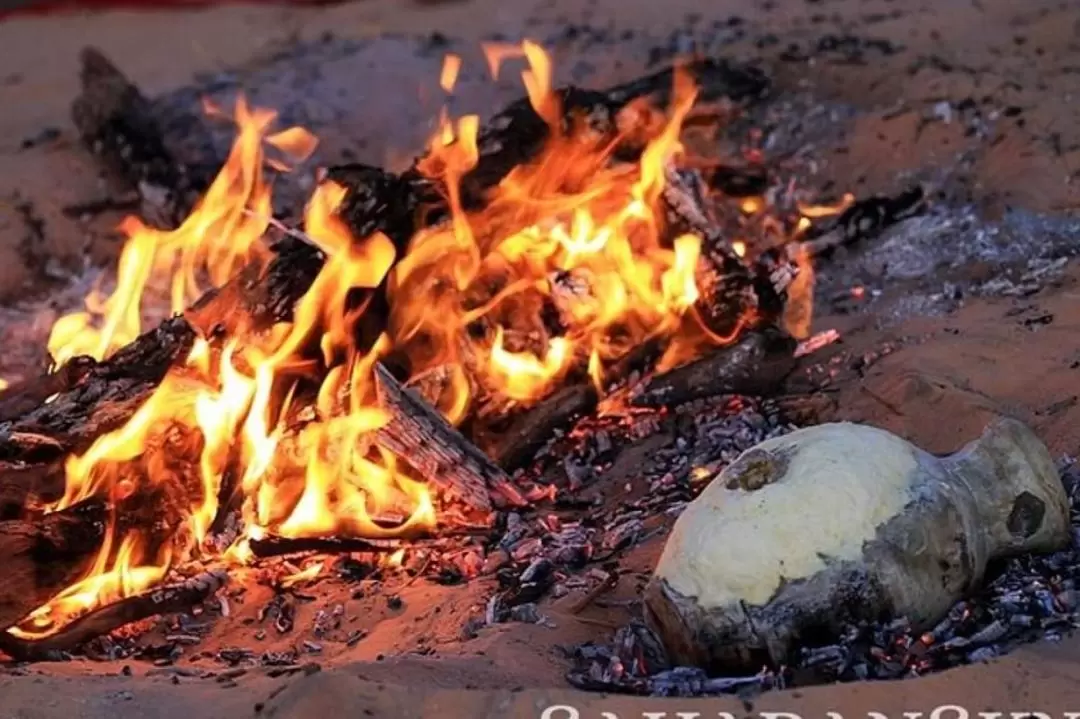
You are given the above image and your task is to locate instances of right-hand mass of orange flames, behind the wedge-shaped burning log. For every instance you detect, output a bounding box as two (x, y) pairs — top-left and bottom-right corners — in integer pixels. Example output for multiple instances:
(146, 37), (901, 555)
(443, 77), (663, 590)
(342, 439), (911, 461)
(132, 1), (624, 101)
(391, 42), (700, 408)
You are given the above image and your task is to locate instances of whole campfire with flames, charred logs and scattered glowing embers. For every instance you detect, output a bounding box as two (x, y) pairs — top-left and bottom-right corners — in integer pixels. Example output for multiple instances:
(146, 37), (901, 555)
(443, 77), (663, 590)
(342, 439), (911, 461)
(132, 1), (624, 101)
(0, 11), (1078, 712)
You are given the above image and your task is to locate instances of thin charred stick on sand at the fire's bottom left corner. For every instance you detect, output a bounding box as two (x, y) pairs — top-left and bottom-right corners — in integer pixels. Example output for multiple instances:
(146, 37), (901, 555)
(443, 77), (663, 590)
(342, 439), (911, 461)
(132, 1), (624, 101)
(0, 570), (229, 662)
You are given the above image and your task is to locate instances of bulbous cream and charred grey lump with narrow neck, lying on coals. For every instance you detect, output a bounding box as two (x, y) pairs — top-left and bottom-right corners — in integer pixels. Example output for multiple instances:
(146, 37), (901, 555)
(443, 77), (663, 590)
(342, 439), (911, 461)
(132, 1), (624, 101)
(645, 420), (1070, 671)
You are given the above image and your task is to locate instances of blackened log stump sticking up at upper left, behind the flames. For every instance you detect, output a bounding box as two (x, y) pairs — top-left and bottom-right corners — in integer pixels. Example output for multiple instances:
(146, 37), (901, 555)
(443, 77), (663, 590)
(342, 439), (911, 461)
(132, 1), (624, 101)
(71, 48), (204, 226)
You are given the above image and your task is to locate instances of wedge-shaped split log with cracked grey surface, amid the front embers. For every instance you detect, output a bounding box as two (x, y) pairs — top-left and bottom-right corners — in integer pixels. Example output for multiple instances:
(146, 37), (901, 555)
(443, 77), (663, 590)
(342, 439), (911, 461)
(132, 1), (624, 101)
(375, 365), (526, 511)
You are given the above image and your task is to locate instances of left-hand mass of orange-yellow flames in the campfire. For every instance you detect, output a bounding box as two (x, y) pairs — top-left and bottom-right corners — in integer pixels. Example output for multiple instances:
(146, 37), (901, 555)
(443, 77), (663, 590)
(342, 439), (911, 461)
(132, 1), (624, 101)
(12, 103), (435, 637)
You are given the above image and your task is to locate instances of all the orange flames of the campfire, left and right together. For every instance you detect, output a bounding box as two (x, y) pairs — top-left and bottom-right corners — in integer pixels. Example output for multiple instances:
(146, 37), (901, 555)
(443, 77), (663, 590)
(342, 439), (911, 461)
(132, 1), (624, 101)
(12, 41), (842, 637)
